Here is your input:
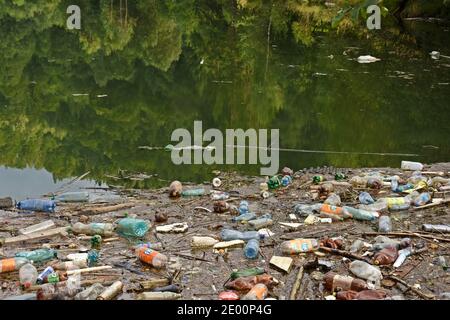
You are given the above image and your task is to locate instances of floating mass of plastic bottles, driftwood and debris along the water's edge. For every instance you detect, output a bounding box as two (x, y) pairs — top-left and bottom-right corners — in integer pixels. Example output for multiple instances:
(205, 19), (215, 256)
(0, 161), (450, 300)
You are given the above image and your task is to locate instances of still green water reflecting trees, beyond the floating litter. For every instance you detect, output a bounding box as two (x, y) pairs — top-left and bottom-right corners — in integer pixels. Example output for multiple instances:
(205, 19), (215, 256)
(0, 8), (450, 198)
